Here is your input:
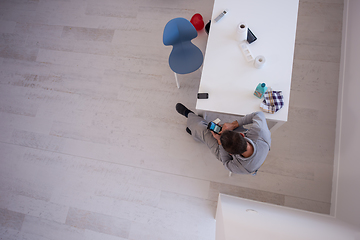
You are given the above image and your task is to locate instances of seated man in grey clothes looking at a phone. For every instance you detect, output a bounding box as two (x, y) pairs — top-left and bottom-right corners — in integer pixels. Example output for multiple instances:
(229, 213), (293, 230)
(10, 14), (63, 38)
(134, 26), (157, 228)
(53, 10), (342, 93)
(176, 103), (271, 174)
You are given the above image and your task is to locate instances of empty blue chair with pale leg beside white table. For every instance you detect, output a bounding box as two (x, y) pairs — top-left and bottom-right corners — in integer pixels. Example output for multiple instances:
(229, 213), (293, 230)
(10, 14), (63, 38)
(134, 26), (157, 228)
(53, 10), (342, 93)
(163, 18), (203, 88)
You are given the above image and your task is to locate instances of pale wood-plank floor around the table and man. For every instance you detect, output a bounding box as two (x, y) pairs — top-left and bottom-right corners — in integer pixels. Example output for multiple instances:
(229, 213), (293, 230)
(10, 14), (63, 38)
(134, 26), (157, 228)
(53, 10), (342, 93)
(0, 0), (343, 240)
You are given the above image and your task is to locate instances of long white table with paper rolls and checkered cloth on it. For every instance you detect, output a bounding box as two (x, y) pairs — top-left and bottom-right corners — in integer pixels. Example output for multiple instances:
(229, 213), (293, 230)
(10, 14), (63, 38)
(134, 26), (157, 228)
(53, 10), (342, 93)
(196, 0), (299, 131)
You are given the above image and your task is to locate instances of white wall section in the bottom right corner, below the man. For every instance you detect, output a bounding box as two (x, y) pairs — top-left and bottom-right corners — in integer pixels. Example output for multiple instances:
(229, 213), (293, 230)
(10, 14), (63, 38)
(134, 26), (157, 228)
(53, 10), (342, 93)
(216, 194), (360, 240)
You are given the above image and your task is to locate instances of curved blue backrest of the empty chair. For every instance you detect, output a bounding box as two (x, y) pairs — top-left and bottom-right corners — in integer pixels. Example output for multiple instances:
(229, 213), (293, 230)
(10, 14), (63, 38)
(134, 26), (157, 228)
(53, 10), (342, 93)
(163, 18), (197, 46)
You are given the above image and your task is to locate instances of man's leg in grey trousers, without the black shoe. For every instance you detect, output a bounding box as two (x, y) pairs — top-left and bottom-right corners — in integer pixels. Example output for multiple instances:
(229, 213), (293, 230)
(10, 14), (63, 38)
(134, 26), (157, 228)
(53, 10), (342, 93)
(187, 112), (220, 159)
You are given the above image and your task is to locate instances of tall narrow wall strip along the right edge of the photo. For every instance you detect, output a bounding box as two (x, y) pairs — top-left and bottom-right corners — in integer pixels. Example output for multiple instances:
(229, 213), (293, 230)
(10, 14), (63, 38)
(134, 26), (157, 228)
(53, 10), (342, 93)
(331, 0), (360, 229)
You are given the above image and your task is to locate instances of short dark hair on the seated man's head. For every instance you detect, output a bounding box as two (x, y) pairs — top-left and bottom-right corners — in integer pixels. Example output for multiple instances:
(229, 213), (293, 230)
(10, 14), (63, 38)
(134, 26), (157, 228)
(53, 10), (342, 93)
(220, 131), (247, 154)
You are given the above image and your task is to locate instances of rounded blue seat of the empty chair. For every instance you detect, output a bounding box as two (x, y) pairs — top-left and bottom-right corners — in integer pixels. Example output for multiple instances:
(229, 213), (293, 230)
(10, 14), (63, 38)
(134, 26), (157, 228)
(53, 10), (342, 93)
(169, 42), (203, 74)
